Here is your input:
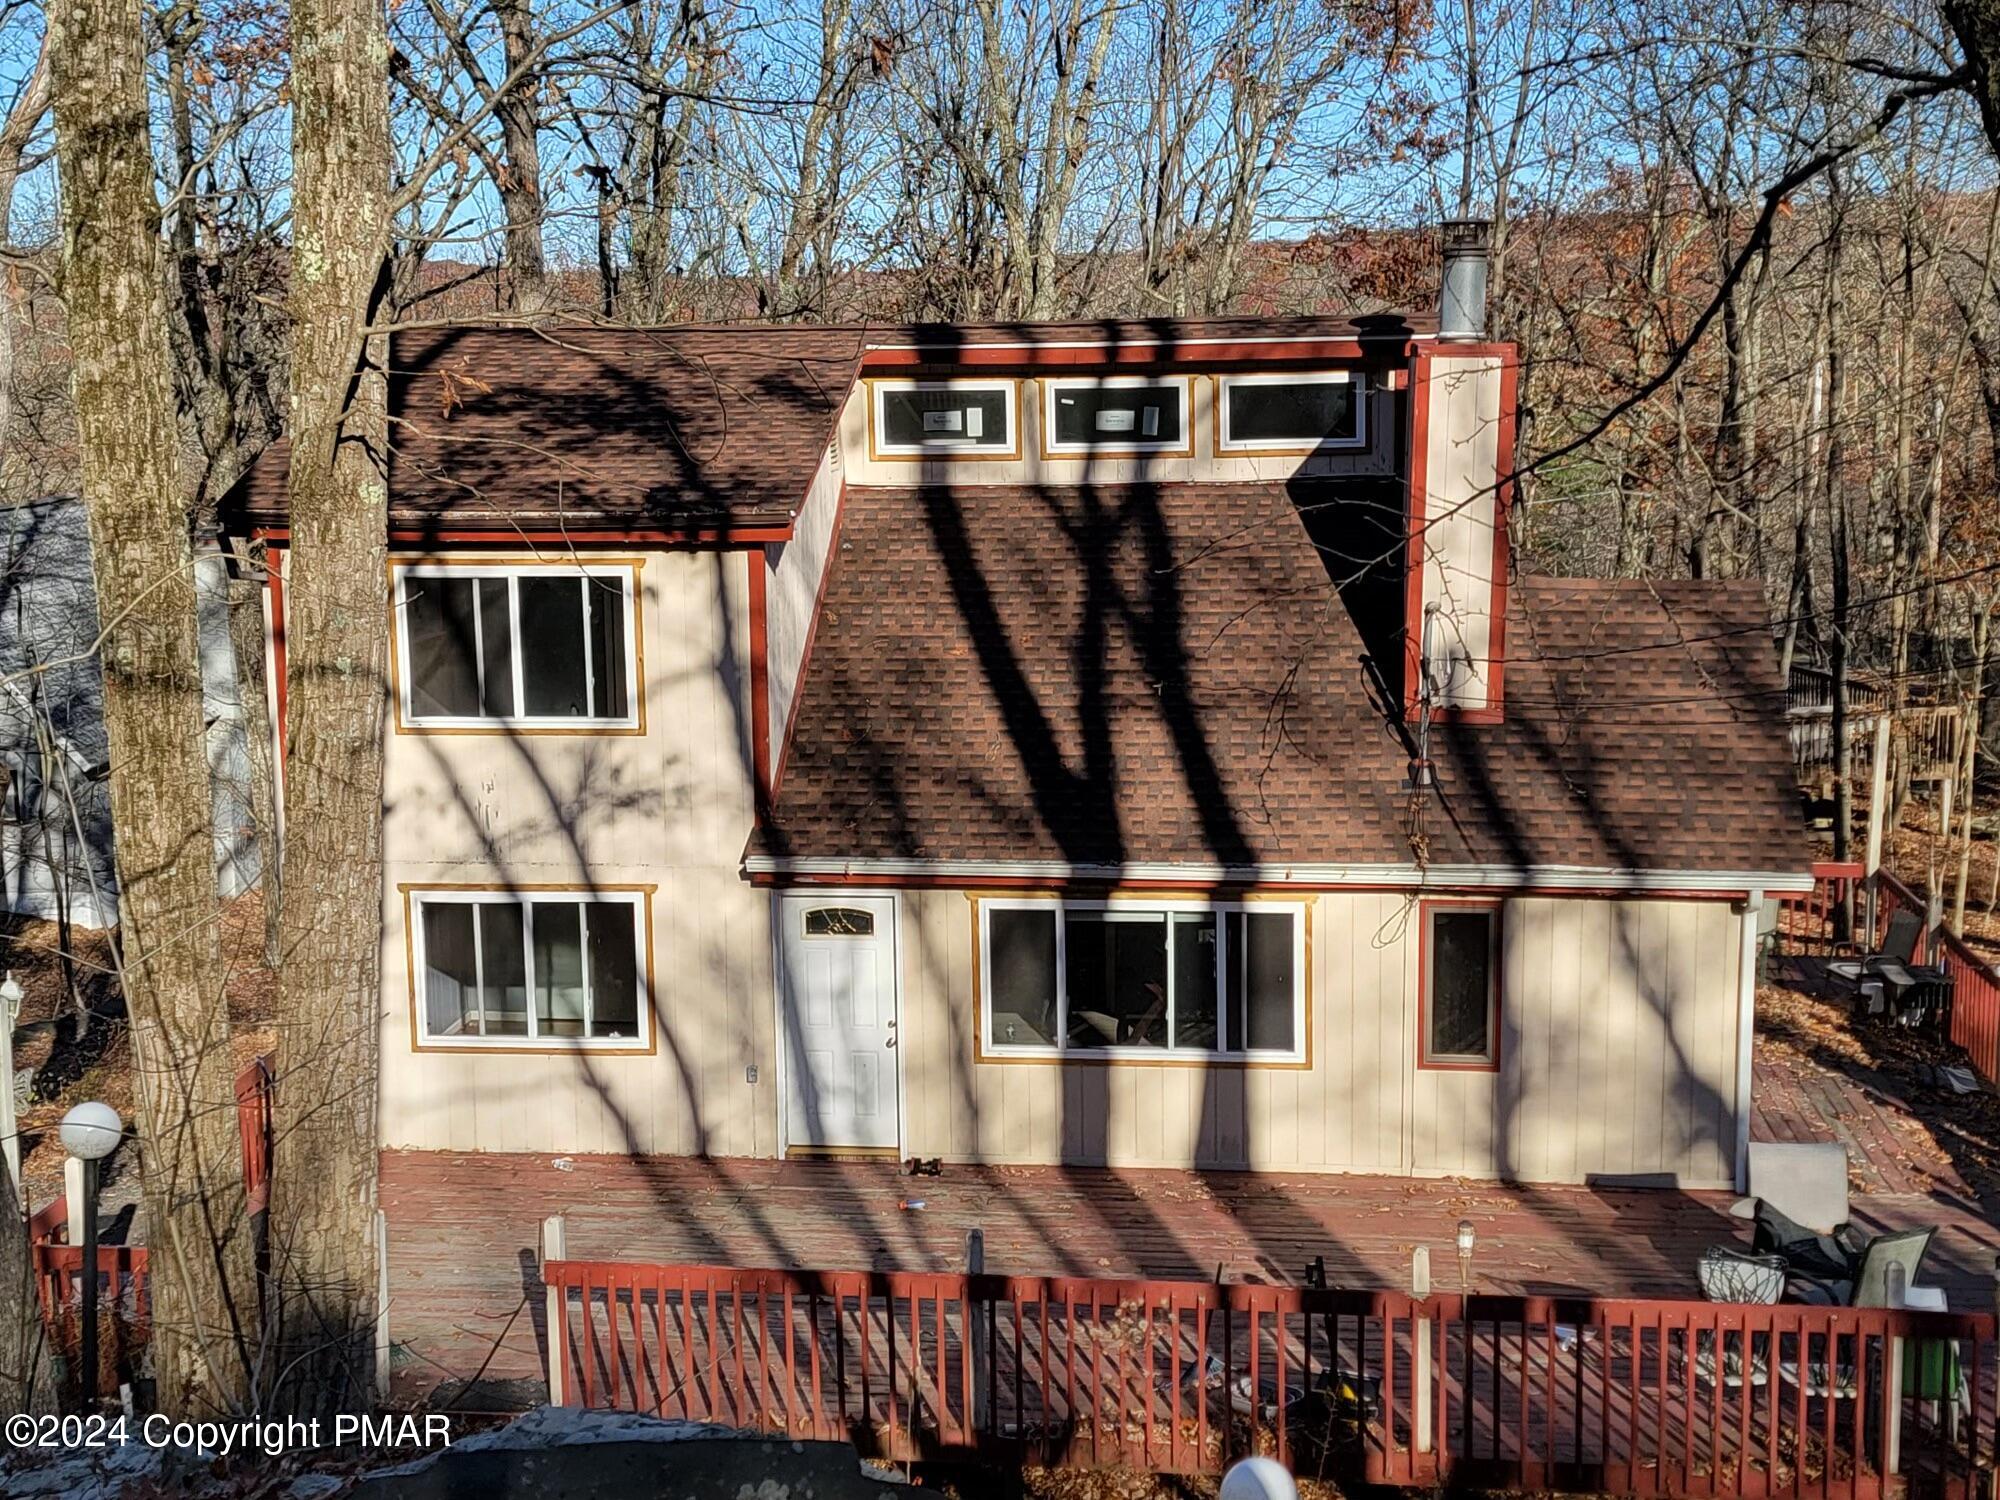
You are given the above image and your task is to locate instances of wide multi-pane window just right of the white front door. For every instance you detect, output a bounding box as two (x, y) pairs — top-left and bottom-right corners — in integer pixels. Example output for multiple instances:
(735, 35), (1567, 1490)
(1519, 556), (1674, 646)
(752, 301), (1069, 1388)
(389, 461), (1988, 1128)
(980, 898), (1308, 1062)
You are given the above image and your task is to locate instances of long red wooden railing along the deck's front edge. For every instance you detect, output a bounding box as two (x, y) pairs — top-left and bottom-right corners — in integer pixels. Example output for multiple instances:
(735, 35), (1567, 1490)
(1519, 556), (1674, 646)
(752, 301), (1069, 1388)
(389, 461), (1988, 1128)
(542, 1260), (1996, 1500)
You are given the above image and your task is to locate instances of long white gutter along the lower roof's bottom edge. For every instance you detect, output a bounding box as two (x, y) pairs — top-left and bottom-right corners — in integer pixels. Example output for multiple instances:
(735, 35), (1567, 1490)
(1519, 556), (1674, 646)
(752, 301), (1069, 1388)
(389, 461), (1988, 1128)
(744, 854), (1812, 894)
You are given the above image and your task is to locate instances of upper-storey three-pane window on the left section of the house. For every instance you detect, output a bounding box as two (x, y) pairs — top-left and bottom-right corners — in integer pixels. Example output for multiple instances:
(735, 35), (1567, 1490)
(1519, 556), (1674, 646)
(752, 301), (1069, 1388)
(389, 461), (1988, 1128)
(394, 562), (640, 730)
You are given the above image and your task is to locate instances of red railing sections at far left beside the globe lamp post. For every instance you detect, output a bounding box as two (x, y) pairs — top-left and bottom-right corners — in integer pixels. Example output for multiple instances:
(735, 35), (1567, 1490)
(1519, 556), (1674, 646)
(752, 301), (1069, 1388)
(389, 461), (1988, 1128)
(28, 1058), (272, 1390)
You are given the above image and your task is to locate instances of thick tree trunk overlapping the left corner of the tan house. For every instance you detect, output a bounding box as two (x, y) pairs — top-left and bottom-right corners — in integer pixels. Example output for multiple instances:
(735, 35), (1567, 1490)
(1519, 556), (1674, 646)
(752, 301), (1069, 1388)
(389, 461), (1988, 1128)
(270, 0), (390, 1414)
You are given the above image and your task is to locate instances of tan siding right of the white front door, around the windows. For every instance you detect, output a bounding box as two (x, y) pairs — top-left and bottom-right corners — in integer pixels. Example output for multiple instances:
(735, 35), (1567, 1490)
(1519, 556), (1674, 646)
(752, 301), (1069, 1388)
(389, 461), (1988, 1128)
(902, 890), (1740, 1186)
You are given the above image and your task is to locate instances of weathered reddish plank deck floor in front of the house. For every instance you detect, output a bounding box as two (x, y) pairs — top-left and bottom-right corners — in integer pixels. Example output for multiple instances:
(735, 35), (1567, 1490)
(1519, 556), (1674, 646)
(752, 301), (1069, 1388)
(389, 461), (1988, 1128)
(382, 1152), (2000, 1408)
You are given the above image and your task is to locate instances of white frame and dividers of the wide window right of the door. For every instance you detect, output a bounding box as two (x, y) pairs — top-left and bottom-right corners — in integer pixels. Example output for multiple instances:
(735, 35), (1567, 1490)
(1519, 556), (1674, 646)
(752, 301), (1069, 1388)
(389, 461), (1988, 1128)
(980, 896), (1312, 1062)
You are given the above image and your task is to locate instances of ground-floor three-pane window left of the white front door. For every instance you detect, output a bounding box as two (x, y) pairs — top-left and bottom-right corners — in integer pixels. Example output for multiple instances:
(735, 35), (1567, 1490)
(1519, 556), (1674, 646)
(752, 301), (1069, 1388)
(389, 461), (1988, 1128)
(408, 888), (652, 1052)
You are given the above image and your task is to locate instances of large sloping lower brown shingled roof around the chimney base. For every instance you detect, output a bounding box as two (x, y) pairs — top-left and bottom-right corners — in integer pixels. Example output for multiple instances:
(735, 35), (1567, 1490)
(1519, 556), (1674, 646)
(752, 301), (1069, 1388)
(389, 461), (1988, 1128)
(752, 484), (1808, 870)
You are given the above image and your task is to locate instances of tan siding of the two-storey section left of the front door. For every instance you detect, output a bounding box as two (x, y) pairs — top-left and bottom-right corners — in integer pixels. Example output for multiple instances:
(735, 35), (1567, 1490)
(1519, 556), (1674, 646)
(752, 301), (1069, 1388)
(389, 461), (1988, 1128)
(380, 552), (778, 1156)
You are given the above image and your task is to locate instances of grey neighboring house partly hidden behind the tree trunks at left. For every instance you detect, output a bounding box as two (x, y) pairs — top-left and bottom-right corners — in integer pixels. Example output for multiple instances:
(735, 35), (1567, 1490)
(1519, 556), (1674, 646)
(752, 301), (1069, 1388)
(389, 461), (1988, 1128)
(0, 496), (258, 928)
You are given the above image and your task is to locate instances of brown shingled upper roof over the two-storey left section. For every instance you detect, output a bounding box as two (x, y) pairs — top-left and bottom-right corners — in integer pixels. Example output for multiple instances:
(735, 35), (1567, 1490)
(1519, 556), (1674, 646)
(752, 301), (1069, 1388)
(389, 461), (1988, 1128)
(226, 326), (862, 530)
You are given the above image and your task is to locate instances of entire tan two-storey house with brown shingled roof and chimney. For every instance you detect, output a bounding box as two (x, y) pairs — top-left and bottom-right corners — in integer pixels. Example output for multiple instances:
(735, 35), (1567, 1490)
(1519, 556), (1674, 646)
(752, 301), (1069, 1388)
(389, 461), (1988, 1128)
(232, 253), (1810, 1208)
